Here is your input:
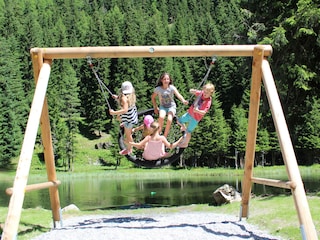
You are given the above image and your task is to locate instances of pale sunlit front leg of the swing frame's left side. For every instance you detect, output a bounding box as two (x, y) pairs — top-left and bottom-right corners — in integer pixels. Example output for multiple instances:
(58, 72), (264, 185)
(1, 58), (51, 240)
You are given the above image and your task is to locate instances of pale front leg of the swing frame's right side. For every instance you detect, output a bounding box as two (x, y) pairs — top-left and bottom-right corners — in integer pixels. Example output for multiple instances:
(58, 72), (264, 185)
(262, 60), (318, 240)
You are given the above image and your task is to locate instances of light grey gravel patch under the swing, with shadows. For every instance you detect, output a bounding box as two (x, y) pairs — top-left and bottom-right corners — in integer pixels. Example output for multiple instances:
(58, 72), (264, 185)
(34, 212), (281, 240)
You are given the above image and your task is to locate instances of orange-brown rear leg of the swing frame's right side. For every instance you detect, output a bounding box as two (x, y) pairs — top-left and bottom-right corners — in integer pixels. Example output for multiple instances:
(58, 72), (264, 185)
(241, 46), (264, 217)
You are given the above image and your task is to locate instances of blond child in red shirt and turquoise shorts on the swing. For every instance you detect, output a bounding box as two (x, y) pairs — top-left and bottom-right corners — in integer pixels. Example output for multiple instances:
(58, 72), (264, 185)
(177, 83), (215, 148)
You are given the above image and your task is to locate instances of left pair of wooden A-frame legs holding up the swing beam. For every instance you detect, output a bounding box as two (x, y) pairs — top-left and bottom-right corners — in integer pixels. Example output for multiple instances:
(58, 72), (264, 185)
(1, 51), (60, 240)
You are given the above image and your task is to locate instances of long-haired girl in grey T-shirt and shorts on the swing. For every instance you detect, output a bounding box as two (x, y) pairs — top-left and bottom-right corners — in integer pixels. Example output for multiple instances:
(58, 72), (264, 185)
(151, 72), (188, 137)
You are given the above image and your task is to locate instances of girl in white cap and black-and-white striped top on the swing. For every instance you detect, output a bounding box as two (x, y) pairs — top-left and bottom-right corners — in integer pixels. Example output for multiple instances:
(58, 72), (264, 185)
(109, 81), (138, 155)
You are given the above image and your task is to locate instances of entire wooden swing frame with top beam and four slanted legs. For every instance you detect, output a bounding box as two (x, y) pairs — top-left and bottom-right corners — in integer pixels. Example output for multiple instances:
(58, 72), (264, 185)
(1, 45), (318, 240)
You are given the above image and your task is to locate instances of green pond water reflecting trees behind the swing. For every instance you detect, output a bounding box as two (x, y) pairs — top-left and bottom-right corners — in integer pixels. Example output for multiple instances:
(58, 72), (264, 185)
(0, 172), (320, 210)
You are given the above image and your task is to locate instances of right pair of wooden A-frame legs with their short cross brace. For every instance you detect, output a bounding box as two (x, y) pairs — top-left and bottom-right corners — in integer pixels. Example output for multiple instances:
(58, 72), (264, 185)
(240, 47), (318, 240)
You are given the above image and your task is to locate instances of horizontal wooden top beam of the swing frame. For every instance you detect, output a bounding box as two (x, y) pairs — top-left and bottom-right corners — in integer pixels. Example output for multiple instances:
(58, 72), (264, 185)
(31, 45), (272, 59)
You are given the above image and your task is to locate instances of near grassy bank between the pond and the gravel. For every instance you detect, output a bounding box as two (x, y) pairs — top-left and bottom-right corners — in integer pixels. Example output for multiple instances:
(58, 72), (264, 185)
(0, 196), (320, 240)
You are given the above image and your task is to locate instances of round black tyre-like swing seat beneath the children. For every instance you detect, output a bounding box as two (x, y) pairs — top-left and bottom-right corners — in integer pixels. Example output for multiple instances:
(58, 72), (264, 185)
(118, 108), (185, 168)
